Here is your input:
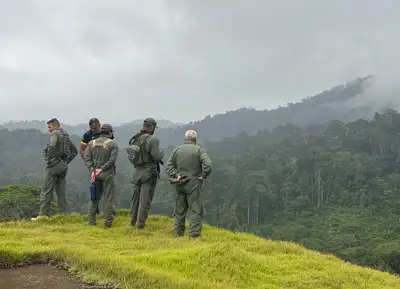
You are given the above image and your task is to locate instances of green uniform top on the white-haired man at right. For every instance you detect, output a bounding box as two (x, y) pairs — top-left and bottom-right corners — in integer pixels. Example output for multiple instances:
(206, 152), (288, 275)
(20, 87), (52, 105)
(165, 143), (211, 179)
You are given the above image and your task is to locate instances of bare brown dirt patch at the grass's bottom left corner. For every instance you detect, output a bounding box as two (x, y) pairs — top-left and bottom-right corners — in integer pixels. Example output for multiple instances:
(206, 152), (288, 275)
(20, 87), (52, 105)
(0, 265), (88, 289)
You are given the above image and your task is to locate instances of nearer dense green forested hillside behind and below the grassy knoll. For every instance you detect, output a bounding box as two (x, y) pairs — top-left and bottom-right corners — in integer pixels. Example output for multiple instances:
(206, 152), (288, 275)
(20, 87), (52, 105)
(0, 110), (400, 273)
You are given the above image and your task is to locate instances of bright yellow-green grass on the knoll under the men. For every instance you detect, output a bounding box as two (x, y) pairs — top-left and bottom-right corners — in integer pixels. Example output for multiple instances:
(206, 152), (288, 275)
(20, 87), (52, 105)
(0, 211), (400, 289)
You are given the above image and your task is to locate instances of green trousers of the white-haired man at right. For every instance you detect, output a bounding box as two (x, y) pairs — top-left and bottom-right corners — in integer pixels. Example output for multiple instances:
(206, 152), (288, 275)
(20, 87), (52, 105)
(174, 178), (204, 238)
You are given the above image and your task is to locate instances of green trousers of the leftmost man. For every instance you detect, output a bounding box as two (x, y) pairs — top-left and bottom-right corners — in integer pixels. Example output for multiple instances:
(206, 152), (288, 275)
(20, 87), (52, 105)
(39, 160), (68, 216)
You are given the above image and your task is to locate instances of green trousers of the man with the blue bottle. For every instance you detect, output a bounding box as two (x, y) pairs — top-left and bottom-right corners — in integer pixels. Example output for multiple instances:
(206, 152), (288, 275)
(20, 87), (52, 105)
(88, 174), (117, 227)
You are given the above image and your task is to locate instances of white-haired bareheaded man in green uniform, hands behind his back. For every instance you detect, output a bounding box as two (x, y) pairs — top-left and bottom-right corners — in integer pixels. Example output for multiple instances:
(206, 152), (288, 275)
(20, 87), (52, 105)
(165, 130), (211, 238)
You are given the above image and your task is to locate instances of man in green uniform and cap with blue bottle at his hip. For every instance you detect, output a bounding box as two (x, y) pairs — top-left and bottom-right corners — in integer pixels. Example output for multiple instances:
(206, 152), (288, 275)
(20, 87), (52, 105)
(84, 124), (118, 228)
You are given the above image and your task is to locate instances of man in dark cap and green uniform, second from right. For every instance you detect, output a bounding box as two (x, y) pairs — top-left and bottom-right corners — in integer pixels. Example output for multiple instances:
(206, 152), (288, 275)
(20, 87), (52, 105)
(127, 118), (164, 229)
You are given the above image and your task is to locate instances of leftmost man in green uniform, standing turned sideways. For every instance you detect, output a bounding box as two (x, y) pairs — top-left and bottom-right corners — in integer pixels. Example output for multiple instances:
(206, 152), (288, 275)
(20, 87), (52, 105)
(31, 118), (78, 220)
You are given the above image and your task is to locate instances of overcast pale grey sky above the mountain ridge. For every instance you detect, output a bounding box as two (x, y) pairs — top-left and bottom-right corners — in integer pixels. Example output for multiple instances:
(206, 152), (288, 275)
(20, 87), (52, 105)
(0, 0), (400, 123)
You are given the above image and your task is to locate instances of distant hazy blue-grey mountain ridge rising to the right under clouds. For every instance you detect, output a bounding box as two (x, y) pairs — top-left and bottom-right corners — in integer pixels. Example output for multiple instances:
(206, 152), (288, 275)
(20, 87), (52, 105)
(3, 76), (382, 146)
